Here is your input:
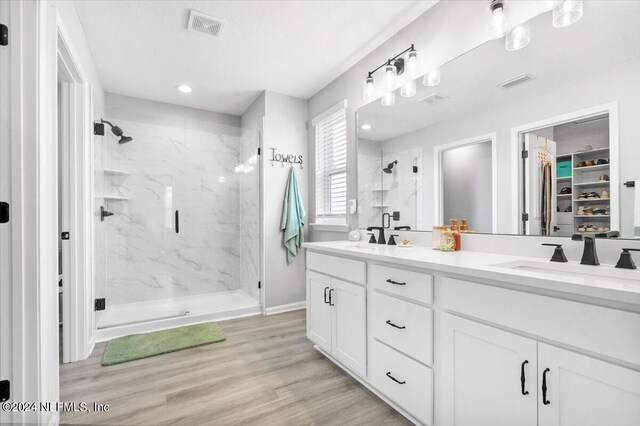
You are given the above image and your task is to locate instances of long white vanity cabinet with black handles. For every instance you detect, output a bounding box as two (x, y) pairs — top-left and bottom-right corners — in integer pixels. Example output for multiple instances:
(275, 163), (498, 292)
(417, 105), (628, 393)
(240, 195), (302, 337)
(307, 243), (640, 426)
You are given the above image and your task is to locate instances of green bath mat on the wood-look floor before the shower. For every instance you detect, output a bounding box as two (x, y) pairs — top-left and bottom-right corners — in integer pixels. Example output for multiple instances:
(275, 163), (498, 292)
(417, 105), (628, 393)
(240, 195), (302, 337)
(102, 322), (226, 365)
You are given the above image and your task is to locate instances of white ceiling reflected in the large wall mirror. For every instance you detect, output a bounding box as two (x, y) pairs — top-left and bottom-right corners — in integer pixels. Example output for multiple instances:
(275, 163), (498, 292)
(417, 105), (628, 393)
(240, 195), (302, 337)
(358, 1), (640, 141)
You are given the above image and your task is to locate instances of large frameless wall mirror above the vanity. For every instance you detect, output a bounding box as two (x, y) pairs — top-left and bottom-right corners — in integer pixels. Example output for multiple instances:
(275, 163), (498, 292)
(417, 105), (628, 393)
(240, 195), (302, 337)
(357, 1), (640, 238)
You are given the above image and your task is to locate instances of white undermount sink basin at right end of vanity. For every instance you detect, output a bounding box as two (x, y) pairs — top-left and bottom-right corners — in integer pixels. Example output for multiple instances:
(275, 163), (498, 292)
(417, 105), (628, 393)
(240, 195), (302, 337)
(491, 260), (640, 285)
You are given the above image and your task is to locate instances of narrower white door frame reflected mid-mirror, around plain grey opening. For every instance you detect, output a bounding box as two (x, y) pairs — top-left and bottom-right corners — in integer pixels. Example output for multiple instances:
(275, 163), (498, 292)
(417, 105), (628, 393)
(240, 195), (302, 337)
(433, 132), (498, 234)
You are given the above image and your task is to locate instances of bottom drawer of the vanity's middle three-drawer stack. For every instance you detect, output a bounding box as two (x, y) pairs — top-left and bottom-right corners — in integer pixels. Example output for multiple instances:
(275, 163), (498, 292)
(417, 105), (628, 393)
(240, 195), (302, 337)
(369, 340), (433, 425)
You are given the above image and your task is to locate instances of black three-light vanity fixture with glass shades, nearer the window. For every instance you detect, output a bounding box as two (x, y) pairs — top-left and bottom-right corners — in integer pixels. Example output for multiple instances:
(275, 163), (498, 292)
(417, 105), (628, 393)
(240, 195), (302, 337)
(362, 44), (418, 106)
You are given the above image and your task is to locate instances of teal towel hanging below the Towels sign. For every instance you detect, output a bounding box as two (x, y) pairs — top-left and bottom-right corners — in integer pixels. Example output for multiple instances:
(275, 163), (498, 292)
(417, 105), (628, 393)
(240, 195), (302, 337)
(280, 166), (305, 263)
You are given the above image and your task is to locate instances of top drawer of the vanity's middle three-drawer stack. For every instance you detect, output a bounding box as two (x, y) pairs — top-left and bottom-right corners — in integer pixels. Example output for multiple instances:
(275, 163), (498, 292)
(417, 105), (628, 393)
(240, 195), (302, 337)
(369, 264), (433, 305)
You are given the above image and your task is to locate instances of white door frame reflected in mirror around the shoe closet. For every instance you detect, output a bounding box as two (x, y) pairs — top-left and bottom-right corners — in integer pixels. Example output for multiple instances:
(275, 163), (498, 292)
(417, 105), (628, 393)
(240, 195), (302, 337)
(510, 101), (620, 235)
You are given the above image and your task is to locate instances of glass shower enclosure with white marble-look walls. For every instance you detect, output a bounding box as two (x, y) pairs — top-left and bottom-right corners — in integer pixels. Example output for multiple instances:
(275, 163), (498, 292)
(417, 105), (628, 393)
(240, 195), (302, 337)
(94, 108), (261, 333)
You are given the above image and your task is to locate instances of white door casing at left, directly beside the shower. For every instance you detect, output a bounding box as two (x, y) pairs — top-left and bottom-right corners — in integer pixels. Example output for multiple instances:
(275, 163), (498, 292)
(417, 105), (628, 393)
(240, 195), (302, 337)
(56, 19), (94, 362)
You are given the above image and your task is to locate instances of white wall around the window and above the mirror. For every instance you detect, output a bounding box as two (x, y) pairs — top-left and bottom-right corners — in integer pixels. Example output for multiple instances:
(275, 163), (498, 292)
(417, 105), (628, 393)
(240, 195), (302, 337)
(308, 0), (544, 241)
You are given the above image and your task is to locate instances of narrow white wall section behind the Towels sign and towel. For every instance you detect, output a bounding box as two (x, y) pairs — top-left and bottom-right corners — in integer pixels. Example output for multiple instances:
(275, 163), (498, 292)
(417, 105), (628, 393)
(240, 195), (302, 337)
(262, 92), (311, 309)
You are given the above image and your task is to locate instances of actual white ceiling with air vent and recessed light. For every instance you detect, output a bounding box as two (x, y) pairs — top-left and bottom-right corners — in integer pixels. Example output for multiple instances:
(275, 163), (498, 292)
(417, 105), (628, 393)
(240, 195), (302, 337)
(75, 0), (437, 115)
